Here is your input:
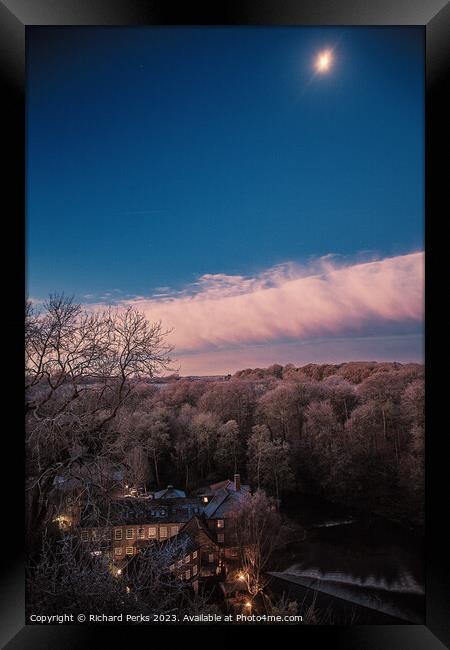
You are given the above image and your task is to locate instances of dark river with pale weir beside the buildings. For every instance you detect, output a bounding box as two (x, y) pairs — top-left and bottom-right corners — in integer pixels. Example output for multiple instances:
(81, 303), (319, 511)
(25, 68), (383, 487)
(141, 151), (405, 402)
(271, 497), (425, 624)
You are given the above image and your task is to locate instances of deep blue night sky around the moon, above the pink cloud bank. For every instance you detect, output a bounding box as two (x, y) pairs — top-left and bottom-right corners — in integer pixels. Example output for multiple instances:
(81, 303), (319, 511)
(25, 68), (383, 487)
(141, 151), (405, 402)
(27, 27), (424, 297)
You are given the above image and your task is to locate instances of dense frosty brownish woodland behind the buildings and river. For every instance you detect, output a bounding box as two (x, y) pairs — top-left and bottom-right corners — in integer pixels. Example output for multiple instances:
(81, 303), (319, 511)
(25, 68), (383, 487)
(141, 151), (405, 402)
(110, 363), (424, 525)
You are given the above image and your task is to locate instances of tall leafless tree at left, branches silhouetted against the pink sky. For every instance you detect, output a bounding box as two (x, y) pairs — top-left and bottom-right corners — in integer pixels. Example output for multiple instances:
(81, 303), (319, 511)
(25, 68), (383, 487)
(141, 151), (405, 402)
(25, 295), (172, 531)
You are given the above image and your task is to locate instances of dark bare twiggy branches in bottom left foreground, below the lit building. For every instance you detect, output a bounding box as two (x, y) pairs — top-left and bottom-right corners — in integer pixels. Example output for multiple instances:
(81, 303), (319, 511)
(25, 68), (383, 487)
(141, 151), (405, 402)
(27, 534), (206, 615)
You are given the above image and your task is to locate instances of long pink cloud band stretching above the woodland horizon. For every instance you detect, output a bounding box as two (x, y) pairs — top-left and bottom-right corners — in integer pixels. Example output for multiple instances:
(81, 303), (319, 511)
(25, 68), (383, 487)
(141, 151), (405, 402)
(117, 252), (424, 354)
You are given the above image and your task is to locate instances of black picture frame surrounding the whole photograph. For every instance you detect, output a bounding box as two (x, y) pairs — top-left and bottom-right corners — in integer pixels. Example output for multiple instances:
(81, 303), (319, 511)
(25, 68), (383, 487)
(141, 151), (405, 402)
(0, 0), (450, 650)
